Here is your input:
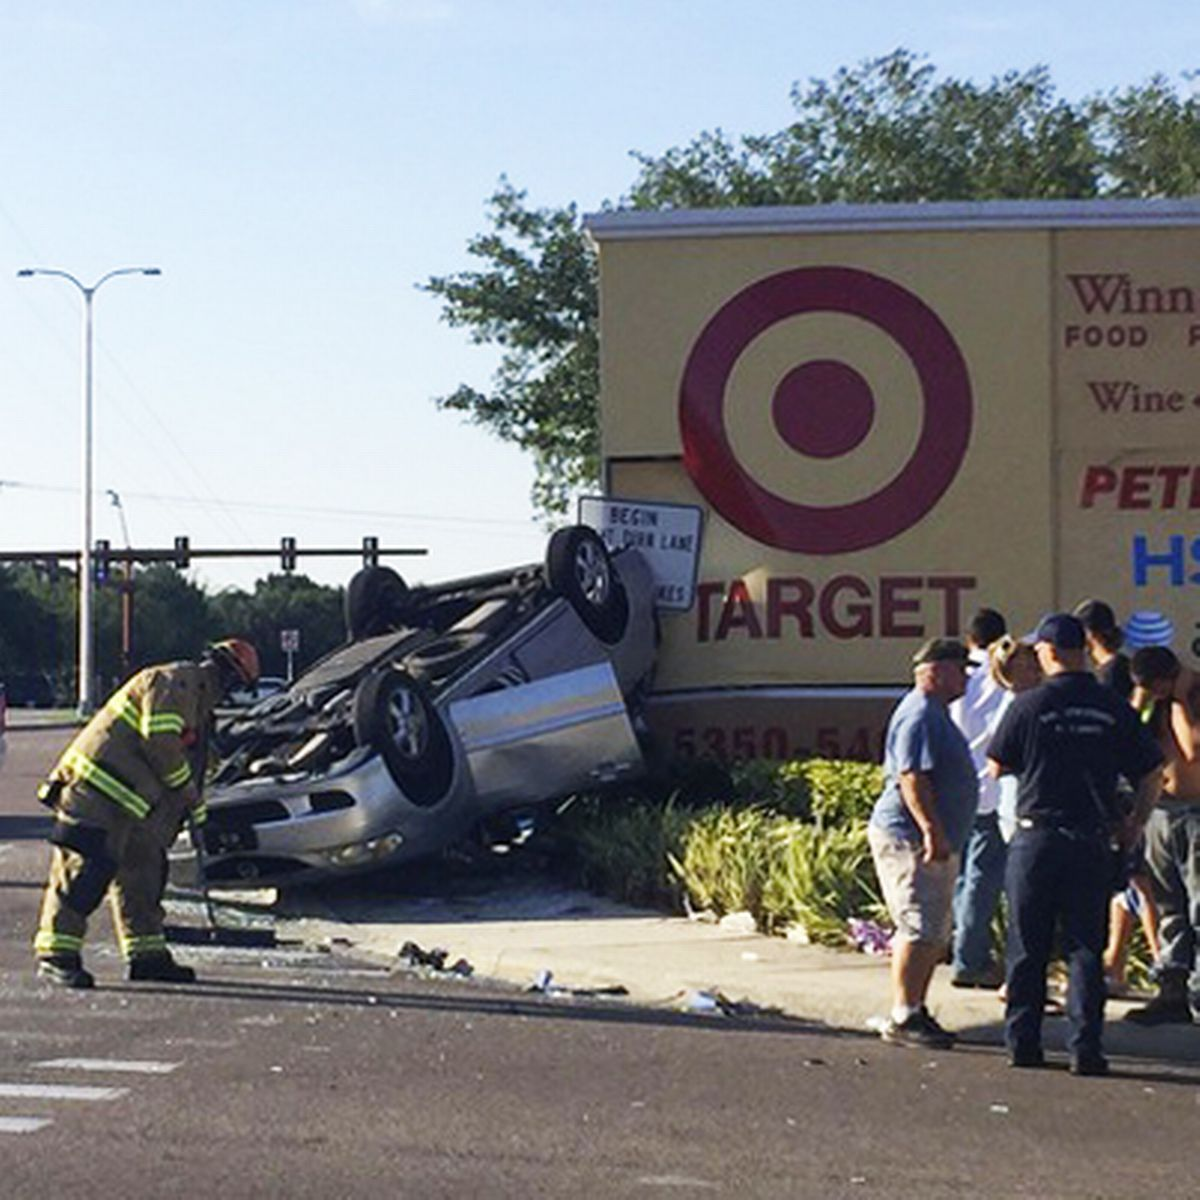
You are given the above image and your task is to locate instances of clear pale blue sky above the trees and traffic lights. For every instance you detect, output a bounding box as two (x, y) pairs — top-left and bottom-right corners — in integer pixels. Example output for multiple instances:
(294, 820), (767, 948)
(0, 0), (1200, 587)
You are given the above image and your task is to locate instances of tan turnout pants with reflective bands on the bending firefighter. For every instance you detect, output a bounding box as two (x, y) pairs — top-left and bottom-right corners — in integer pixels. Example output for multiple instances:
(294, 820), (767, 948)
(34, 788), (187, 959)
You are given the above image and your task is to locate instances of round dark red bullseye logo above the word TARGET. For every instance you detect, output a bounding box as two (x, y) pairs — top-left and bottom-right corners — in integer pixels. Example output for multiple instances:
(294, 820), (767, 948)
(679, 266), (971, 554)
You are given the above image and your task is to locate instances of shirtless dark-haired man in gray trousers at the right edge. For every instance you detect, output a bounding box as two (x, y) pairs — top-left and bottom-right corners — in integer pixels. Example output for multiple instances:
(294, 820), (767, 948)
(1128, 646), (1200, 1025)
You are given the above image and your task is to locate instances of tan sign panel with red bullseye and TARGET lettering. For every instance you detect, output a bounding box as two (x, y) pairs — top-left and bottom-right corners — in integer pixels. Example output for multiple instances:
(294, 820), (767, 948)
(600, 230), (1061, 691)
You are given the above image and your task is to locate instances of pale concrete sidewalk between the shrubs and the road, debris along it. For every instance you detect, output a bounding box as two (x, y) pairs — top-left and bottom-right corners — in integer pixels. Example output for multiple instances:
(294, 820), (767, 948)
(265, 881), (1200, 1062)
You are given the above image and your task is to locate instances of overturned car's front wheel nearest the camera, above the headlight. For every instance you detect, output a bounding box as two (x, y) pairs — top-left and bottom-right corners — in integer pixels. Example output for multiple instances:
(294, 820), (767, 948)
(354, 670), (454, 805)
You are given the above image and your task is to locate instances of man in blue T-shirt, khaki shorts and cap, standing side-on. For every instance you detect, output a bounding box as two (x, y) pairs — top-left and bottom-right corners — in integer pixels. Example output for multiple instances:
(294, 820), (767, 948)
(866, 637), (979, 1049)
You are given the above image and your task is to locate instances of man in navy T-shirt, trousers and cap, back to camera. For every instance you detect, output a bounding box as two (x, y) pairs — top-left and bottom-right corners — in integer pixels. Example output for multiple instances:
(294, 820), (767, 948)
(988, 613), (1163, 1075)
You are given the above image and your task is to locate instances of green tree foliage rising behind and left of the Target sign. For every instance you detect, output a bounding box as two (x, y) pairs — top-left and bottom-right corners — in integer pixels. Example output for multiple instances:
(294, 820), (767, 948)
(424, 50), (1200, 515)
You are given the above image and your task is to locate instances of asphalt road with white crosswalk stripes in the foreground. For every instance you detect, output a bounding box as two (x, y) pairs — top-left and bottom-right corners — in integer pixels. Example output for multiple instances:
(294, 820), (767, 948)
(0, 731), (1200, 1200)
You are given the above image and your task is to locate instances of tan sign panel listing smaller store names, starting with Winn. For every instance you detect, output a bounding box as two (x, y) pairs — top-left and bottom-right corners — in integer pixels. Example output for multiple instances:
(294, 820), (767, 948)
(1052, 229), (1200, 666)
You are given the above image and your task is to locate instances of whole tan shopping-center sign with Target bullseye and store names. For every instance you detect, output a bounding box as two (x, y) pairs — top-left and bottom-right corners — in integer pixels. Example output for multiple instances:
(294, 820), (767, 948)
(588, 202), (1200, 754)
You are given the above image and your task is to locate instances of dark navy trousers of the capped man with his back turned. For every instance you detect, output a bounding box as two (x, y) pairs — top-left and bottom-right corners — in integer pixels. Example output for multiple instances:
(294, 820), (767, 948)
(1004, 829), (1111, 1055)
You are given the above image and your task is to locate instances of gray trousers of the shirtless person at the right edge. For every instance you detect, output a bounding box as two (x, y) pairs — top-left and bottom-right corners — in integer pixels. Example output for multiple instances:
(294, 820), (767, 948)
(1146, 804), (1200, 1010)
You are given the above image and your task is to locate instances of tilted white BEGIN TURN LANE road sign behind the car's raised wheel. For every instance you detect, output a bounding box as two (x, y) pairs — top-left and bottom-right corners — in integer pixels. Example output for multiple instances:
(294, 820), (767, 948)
(580, 496), (703, 612)
